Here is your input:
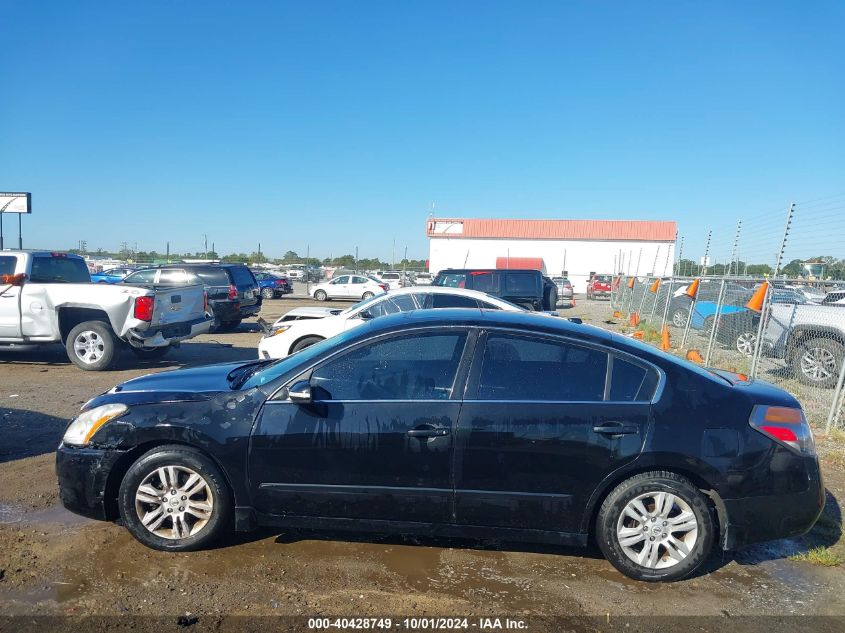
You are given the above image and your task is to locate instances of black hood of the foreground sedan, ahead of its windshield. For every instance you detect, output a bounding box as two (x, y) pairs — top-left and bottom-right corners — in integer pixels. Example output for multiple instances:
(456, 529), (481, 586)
(83, 361), (255, 409)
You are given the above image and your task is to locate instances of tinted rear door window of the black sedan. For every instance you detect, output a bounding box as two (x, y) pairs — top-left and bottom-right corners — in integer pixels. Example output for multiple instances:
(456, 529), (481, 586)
(477, 334), (608, 402)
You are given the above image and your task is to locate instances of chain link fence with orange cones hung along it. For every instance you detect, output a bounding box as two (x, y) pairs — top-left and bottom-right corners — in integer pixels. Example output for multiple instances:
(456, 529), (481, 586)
(611, 196), (845, 430)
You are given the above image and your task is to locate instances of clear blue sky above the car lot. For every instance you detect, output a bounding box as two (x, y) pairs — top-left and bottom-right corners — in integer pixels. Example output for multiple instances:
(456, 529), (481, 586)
(0, 0), (845, 259)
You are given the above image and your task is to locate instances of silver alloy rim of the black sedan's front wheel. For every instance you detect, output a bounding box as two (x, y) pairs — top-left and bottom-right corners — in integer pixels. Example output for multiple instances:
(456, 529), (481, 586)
(135, 465), (214, 540)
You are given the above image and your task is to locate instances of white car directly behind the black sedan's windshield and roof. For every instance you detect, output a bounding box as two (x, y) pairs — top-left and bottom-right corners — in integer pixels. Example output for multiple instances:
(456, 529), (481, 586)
(258, 286), (524, 360)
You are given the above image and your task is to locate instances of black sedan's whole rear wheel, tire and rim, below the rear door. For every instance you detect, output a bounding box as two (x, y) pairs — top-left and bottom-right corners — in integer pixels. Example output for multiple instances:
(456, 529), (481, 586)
(596, 471), (716, 582)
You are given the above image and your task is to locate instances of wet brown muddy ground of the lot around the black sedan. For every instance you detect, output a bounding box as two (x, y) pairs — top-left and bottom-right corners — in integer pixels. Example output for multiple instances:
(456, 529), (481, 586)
(0, 288), (845, 628)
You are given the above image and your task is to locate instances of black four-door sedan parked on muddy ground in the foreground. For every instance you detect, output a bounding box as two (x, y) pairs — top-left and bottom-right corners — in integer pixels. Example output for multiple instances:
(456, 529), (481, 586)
(57, 309), (824, 580)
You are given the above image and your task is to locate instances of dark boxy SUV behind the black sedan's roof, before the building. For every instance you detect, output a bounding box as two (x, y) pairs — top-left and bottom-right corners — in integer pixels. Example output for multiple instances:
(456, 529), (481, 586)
(432, 268), (557, 310)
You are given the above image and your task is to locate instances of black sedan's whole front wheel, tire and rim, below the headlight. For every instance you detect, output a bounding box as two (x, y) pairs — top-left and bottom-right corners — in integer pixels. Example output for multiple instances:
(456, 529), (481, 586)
(118, 445), (234, 552)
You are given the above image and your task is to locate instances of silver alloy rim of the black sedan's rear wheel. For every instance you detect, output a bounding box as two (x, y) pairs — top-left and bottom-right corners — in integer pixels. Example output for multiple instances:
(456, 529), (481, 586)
(616, 492), (698, 569)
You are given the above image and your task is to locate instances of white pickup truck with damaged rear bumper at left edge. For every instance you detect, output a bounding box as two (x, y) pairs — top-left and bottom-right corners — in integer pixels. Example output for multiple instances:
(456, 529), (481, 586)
(0, 251), (214, 371)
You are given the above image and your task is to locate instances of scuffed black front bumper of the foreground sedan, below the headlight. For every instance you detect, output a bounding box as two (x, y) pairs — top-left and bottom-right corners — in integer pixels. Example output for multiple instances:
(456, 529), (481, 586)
(56, 444), (126, 521)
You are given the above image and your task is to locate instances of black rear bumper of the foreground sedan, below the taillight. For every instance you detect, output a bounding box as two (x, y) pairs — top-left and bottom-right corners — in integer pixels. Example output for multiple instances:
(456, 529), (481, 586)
(722, 458), (825, 550)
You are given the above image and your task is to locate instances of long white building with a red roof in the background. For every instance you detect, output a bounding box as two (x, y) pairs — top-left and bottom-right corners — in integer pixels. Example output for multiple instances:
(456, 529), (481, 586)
(426, 218), (677, 292)
